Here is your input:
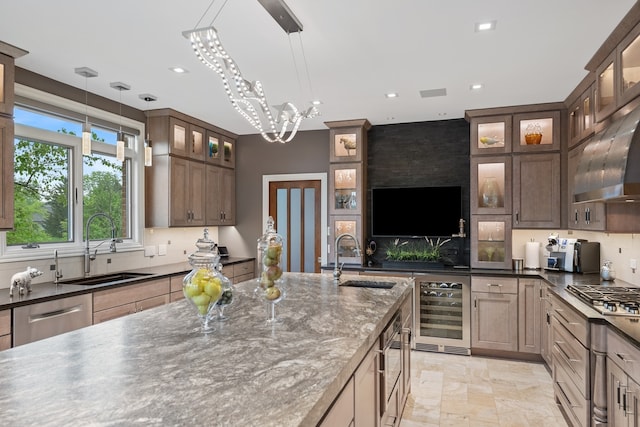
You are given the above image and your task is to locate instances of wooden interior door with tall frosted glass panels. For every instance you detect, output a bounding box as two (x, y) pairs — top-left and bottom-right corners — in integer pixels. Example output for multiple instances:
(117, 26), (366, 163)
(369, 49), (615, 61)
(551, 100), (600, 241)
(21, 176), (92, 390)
(269, 180), (321, 273)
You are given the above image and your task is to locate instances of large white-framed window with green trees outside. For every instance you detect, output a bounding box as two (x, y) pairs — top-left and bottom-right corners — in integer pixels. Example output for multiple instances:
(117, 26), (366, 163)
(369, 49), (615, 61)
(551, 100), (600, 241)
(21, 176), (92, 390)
(3, 86), (144, 258)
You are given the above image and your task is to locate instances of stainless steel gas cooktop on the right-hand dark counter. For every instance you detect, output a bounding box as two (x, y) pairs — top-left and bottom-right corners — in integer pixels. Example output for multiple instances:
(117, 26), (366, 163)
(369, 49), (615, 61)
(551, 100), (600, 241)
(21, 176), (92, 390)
(567, 285), (640, 317)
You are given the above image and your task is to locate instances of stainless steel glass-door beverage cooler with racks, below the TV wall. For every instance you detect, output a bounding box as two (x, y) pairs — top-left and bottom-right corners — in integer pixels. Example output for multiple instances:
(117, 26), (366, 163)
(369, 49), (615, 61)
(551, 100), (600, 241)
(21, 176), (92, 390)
(414, 274), (471, 356)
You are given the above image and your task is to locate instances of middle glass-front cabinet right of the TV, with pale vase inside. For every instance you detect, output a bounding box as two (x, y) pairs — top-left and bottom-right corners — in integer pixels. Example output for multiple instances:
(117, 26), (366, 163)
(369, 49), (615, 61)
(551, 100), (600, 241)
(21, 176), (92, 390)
(471, 156), (511, 214)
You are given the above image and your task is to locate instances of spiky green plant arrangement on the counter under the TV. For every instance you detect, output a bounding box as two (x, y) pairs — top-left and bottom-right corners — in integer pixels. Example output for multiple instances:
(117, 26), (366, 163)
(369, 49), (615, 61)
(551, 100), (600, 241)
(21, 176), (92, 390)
(383, 236), (451, 268)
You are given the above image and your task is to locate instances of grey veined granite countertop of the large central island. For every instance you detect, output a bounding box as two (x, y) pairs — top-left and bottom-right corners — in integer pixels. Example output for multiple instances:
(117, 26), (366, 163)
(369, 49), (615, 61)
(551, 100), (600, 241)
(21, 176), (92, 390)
(0, 273), (412, 427)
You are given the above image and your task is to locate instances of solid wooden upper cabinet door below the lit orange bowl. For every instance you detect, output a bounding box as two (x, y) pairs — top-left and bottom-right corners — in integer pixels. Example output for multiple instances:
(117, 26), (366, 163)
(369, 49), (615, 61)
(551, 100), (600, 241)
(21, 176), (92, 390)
(512, 153), (561, 228)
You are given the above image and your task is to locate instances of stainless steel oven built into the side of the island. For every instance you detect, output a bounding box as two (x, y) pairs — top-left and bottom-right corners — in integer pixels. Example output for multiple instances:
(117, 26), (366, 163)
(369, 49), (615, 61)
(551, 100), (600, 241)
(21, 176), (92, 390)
(380, 313), (402, 416)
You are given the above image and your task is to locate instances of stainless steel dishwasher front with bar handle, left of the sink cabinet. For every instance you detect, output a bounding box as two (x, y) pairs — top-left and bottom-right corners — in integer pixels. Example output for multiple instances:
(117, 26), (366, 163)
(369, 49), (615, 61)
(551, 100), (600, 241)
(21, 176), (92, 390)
(13, 294), (93, 347)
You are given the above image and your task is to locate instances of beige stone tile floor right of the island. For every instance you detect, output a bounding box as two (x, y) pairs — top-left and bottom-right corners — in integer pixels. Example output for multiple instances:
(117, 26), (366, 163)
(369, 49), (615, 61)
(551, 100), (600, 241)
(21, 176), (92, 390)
(400, 351), (567, 427)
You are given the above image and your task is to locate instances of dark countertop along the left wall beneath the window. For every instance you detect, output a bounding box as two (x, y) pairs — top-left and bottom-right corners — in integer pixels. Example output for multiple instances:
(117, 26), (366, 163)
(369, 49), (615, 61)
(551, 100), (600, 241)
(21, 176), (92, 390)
(0, 257), (255, 310)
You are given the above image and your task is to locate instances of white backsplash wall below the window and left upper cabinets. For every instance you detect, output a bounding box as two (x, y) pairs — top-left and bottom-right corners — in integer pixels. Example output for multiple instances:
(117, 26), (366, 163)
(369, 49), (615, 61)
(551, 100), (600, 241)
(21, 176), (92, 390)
(0, 227), (212, 289)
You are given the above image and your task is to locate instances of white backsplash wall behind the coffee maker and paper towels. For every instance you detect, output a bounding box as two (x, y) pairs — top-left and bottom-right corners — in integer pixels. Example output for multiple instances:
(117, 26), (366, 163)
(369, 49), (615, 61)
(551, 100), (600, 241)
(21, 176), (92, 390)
(512, 230), (640, 286)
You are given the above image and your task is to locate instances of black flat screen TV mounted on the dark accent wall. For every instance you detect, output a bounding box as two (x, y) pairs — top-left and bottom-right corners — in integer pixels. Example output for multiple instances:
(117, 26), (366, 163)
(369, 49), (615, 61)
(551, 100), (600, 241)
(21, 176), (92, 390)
(371, 186), (462, 237)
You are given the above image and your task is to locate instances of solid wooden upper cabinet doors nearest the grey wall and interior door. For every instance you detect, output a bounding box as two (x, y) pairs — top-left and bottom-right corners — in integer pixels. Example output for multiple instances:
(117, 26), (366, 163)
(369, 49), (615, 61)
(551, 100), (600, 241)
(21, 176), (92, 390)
(205, 165), (236, 225)
